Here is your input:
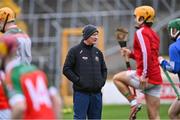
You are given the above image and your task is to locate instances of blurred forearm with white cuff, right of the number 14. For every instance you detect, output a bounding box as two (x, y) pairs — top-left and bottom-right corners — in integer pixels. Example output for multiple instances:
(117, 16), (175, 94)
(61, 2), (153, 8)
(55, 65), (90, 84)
(49, 86), (62, 119)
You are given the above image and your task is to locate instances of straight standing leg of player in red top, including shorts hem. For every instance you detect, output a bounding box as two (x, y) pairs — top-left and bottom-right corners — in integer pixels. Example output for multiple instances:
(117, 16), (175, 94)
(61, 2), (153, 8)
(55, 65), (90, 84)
(145, 85), (161, 120)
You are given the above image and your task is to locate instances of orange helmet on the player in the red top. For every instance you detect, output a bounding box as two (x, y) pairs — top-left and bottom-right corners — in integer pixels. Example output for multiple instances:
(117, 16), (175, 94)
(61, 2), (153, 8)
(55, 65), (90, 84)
(134, 6), (155, 23)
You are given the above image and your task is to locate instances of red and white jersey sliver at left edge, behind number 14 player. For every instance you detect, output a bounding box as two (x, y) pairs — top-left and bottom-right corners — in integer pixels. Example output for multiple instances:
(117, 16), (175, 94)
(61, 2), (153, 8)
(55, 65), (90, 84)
(0, 71), (10, 110)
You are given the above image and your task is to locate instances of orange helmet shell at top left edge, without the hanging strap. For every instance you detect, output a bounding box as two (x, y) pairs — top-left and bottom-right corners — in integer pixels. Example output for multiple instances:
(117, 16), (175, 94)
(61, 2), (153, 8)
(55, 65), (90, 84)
(0, 7), (15, 22)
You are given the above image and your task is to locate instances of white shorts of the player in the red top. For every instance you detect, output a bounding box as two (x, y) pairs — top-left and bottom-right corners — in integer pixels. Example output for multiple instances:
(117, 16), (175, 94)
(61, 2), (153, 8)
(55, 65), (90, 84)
(127, 70), (161, 97)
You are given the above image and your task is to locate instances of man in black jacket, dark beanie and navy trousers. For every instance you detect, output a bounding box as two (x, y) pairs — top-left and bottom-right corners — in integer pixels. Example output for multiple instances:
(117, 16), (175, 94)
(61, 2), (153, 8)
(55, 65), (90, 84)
(63, 25), (107, 119)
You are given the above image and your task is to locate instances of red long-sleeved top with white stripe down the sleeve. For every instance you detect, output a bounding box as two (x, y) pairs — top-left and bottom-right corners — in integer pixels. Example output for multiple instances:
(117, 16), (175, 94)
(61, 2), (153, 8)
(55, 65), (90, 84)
(131, 25), (162, 84)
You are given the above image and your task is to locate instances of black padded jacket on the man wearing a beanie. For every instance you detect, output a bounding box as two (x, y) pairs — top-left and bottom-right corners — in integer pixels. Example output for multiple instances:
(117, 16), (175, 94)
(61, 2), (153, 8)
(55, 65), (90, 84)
(63, 41), (107, 93)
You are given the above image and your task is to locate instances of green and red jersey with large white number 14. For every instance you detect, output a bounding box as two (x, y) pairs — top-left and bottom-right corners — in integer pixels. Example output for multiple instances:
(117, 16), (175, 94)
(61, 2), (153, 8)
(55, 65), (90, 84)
(7, 65), (55, 119)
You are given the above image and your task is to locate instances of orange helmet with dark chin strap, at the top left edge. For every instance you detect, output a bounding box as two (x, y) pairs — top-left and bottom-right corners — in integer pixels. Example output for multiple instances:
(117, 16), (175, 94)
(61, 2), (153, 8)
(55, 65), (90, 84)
(0, 7), (15, 33)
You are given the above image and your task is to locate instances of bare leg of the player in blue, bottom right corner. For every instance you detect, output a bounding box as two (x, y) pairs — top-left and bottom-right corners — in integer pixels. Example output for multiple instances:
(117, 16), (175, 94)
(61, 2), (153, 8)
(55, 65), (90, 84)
(168, 99), (180, 119)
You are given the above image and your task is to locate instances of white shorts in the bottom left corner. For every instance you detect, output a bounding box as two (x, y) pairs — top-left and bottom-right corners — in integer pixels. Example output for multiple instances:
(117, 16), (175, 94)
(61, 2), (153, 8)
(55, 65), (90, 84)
(0, 109), (11, 120)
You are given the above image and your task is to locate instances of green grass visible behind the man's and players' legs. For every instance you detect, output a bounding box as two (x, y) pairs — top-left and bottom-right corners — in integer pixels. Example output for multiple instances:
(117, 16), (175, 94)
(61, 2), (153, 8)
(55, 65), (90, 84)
(63, 104), (170, 120)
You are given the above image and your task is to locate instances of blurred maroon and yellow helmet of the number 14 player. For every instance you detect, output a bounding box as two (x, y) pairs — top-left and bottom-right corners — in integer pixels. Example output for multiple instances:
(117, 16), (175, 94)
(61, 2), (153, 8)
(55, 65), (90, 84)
(0, 35), (18, 59)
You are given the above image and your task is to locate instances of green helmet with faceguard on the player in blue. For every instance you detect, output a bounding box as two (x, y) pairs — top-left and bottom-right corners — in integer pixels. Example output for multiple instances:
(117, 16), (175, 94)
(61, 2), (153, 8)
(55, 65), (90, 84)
(168, 18), (180, 41)
